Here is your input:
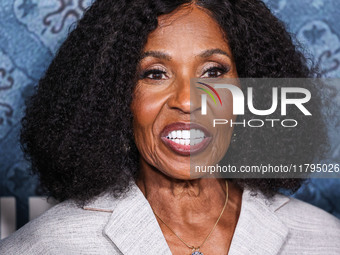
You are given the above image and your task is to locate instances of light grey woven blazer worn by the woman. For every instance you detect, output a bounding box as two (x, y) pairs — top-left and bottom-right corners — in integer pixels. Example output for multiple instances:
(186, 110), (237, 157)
(0, 184), (340, 255)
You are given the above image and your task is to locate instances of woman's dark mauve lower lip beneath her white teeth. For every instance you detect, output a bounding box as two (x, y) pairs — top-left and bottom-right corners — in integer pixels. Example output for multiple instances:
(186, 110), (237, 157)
(162, 137), (211, 156)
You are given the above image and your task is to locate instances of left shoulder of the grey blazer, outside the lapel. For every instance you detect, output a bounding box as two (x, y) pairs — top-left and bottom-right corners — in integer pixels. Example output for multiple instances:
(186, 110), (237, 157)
(0, 194), (116, 255)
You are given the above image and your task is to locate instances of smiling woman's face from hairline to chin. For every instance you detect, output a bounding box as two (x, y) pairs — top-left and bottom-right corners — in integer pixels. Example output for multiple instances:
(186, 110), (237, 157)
(131, 4), (237, 179)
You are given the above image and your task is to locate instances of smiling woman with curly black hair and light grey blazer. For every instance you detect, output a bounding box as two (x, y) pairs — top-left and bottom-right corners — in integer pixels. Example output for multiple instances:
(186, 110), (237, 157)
(0, 0), (340, 255)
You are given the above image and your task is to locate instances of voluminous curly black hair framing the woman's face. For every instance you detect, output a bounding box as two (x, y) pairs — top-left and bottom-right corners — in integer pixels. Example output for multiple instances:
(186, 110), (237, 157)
(21, 0), (328, 203)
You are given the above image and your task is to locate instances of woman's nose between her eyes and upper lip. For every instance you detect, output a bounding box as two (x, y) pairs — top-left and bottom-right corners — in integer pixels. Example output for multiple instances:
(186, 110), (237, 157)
(168, 77), (201, 114)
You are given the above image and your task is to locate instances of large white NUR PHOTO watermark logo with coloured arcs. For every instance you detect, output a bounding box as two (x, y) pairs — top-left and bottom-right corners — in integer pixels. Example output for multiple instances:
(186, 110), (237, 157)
(192, 78), (312, 128)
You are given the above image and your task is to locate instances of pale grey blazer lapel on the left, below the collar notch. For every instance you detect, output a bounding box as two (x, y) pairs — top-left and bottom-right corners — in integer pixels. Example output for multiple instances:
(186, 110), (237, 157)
(104, 184), (171, 255)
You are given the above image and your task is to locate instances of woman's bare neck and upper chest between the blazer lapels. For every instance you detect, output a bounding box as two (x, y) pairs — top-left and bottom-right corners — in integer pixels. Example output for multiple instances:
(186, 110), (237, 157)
(137, 157), (242, 255)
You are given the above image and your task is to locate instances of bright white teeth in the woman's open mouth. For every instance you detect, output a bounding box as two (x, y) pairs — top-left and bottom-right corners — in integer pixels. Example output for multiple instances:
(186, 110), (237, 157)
(167, 129), (205, 145)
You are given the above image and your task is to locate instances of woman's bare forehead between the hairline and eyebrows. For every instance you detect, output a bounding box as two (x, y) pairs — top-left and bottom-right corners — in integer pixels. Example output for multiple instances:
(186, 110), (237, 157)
(145, 6), (228, 50)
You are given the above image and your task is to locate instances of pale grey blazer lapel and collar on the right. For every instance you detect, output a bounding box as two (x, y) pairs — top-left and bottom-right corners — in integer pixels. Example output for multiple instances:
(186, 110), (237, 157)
(228, 189), (289, 255)
